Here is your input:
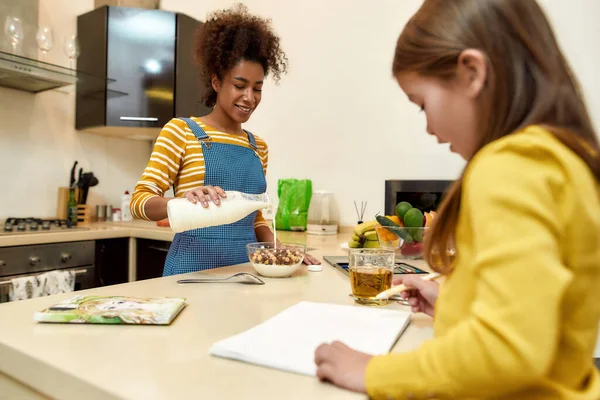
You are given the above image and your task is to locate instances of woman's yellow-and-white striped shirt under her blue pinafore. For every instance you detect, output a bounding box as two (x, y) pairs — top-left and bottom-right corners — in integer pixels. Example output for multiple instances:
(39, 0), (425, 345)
(130, 117), (269, 228)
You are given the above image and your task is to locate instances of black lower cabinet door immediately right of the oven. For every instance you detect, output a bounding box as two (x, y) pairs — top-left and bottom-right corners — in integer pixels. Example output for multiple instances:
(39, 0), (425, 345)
(95, 238), (129, 286)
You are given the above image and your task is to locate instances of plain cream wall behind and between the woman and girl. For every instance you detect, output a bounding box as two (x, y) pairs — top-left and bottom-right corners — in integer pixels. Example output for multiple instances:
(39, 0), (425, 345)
(161, 0), (600, 225)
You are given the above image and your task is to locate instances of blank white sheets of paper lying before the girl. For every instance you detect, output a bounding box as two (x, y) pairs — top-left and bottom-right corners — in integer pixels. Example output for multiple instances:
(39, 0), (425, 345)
(209, 301), (411, 376)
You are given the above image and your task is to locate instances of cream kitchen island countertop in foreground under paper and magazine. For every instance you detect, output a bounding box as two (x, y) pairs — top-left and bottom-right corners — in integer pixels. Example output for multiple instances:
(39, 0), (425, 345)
(0, 234), (433, 400)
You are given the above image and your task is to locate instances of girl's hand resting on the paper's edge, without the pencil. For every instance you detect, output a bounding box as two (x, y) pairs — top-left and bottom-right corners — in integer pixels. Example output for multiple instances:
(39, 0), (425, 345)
(315, 342), (372, 393)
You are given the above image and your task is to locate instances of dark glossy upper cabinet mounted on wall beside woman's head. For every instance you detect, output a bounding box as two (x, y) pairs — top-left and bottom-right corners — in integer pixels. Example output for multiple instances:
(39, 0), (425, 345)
(75, 6), (210, 140)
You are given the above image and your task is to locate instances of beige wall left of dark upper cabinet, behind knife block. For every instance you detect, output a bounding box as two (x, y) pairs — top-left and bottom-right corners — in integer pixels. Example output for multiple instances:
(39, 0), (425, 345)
(0, 0), (151, 219)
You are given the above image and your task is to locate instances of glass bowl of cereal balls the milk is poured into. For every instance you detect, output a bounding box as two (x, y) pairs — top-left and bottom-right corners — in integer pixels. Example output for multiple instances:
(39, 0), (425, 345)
(246, 242), (306, 278)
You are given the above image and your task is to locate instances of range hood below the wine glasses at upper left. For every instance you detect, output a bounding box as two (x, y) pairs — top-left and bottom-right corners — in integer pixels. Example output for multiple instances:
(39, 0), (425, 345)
(0, 51), (114, 95)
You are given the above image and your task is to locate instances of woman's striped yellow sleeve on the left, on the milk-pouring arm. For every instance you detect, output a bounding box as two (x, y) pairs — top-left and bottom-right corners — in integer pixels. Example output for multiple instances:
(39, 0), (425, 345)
(131, 119), (187, 220)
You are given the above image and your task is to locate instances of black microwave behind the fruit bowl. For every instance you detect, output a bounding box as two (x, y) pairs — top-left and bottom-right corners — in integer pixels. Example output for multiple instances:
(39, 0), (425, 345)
(385, 180), (454, 215)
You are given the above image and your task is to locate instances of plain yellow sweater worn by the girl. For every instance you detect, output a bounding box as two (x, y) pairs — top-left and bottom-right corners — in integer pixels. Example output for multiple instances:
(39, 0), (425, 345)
(366, 126), (600, 400)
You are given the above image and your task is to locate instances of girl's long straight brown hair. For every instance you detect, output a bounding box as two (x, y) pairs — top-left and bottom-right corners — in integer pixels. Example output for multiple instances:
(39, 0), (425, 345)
(392, 0), (600, 273)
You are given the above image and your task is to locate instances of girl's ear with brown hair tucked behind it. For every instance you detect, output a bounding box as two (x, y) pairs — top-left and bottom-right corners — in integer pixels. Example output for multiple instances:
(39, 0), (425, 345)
(456, 49), (487, 98)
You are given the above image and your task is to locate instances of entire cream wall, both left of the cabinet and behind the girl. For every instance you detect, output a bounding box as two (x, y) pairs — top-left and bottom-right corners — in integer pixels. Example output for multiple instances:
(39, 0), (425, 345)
(0, 0), (600, 224)
